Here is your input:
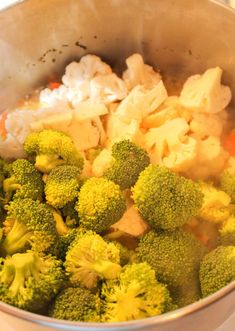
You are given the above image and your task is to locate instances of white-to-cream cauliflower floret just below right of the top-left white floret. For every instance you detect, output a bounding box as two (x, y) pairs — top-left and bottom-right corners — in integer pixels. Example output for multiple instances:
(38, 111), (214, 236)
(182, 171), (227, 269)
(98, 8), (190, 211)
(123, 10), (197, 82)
(90, 73), (127, 104)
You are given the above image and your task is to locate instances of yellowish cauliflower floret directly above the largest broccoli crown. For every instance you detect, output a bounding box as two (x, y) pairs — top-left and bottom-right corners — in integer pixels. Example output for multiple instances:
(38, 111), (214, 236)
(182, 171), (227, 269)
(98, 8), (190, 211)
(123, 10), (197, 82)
(145, 118), (197, 172)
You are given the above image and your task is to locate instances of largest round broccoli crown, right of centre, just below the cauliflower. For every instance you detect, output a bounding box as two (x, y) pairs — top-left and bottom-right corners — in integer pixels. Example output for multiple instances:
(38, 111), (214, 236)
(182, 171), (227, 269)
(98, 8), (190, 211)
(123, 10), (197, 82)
(132, 165), (203, 229)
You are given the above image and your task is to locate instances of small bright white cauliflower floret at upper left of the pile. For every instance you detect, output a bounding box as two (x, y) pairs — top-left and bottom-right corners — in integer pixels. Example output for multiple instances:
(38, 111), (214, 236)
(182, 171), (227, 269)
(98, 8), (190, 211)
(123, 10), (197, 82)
(39, 85), (68, 107)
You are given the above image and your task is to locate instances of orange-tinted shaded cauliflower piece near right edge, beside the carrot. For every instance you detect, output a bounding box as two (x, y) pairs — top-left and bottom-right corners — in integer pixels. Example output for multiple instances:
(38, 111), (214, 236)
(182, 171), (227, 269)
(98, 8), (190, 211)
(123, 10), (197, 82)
(186, 136), (229, 180)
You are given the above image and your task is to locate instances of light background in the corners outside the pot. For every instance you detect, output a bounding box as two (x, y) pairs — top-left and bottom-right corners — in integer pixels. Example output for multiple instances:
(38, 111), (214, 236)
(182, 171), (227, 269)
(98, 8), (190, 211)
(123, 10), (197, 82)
(0, 0), (235, 331)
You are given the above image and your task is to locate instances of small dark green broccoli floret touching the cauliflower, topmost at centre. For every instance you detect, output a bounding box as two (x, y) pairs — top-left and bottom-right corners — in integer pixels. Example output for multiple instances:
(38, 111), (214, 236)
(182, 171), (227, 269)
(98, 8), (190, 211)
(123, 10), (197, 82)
(104, 140), (150, 189)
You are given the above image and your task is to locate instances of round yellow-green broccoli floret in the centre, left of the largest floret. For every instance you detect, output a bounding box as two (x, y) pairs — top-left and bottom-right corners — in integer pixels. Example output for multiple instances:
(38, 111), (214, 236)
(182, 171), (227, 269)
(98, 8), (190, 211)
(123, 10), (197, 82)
(75, 178), (126, 233)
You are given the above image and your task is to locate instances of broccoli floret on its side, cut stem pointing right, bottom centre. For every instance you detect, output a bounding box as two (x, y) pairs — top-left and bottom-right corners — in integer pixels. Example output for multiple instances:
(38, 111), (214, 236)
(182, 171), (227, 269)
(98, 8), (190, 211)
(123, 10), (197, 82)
(65, 231), (121, 288)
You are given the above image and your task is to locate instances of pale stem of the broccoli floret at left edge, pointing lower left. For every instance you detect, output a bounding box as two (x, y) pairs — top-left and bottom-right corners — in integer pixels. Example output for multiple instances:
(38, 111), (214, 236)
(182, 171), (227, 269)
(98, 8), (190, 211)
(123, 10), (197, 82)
(2, 220), (32, 255)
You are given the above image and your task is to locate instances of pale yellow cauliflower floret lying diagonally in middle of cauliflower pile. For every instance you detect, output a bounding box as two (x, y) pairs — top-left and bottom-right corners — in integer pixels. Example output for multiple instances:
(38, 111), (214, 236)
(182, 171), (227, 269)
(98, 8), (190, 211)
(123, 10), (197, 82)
(116, 81), (167, 122)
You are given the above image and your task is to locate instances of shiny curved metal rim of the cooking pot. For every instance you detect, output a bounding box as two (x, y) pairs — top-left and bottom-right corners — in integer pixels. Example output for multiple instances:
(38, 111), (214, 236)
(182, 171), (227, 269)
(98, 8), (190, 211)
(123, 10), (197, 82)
(0, 0), (235, 331)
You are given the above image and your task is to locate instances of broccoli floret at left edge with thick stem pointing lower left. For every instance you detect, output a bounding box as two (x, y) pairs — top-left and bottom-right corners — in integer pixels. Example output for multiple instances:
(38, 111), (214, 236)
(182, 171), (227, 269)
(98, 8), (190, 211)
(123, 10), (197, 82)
(2, 199), (57, 255)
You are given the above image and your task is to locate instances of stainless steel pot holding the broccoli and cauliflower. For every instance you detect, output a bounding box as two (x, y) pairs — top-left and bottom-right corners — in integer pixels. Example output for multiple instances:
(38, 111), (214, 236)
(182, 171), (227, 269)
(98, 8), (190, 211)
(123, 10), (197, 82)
(0, 0), (235, 331)
